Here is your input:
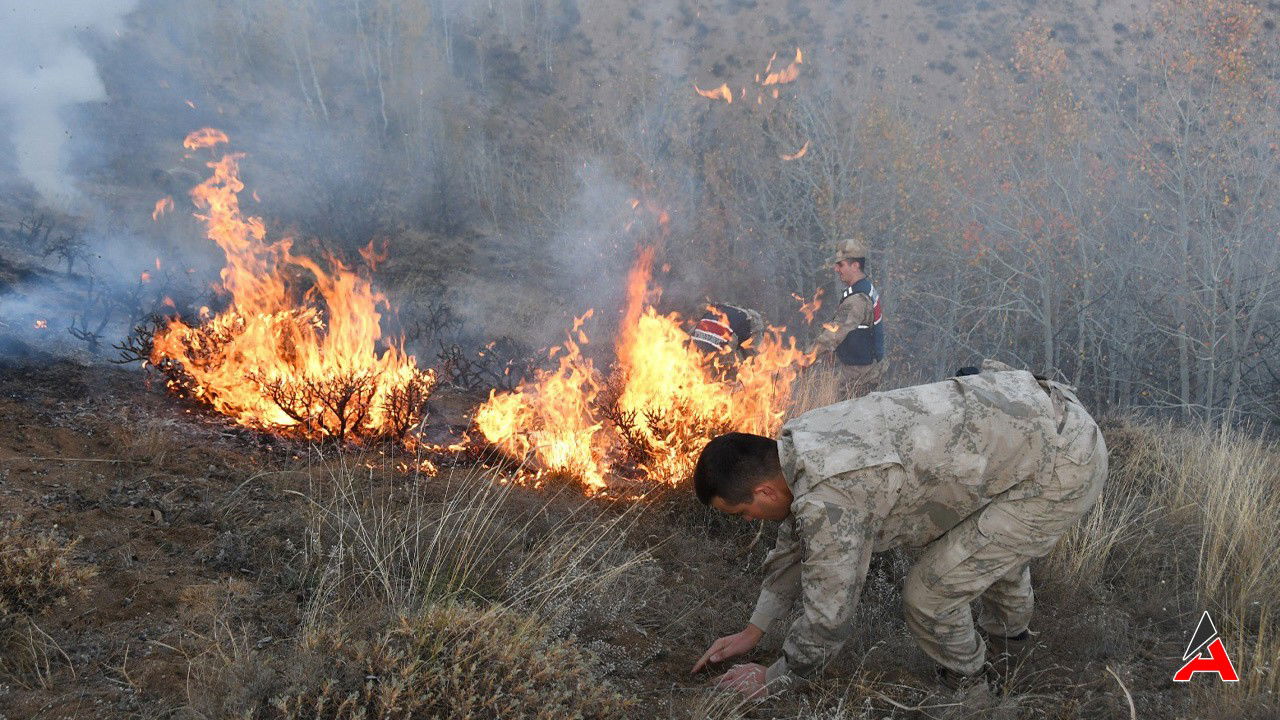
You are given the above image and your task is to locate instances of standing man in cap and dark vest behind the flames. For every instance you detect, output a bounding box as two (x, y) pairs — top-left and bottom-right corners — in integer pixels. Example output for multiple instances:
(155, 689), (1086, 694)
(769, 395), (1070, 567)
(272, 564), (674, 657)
(809, 238), (886, 397)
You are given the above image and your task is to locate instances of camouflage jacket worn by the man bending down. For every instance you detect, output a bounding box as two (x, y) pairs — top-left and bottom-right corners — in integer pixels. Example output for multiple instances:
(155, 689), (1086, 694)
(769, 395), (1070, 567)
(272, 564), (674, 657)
(751, 364), (1061, 689)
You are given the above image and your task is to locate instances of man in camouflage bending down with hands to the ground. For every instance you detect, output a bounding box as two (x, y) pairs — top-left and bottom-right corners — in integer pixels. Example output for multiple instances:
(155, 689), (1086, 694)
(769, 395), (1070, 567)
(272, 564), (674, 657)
(694, 363), (1107, 697)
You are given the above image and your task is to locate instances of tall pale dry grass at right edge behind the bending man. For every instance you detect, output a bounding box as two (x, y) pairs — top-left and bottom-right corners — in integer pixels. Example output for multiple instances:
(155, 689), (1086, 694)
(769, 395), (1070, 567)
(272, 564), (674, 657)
(1048, 424), (1280, 702)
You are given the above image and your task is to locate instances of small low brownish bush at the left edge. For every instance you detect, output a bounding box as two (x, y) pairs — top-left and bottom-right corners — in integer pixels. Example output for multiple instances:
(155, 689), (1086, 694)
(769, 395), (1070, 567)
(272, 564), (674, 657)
(0, 523), (95, 630)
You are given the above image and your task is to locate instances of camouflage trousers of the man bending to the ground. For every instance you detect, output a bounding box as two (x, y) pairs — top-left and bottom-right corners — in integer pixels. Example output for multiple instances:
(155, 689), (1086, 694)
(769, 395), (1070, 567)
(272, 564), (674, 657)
(902, 393), (1107, 674)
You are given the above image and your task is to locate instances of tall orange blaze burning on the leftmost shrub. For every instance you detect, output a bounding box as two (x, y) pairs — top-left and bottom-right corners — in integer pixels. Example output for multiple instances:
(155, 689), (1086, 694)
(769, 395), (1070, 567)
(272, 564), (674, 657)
(151, 128), (435, 445)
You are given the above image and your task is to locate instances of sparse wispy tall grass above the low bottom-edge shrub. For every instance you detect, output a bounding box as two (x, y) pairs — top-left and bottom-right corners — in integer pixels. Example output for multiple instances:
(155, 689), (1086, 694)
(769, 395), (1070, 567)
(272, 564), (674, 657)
(296, 459), (649, 614)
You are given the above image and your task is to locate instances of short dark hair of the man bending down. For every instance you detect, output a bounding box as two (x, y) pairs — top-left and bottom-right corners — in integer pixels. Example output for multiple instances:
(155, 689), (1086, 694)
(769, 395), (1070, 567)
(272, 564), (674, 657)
(694, 433), (782, 505)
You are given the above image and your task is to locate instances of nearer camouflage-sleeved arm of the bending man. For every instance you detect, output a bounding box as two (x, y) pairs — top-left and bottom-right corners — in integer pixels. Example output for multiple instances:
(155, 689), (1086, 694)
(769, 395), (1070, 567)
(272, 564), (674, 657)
(765, 483), (878, 692)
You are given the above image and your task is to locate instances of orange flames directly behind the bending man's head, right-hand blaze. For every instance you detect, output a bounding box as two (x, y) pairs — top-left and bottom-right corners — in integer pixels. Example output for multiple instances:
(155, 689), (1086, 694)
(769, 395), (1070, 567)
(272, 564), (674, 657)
(475, 250), (809, 493)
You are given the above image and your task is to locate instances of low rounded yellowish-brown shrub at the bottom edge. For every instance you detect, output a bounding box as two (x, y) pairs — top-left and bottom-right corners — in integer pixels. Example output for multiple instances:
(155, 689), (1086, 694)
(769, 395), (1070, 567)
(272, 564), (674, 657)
(258, 605), (636, 720)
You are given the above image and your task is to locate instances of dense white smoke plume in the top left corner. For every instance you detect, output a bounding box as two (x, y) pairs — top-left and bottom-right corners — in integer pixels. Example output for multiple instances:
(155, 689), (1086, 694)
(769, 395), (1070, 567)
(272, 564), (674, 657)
(0, 0), (137, 205)
